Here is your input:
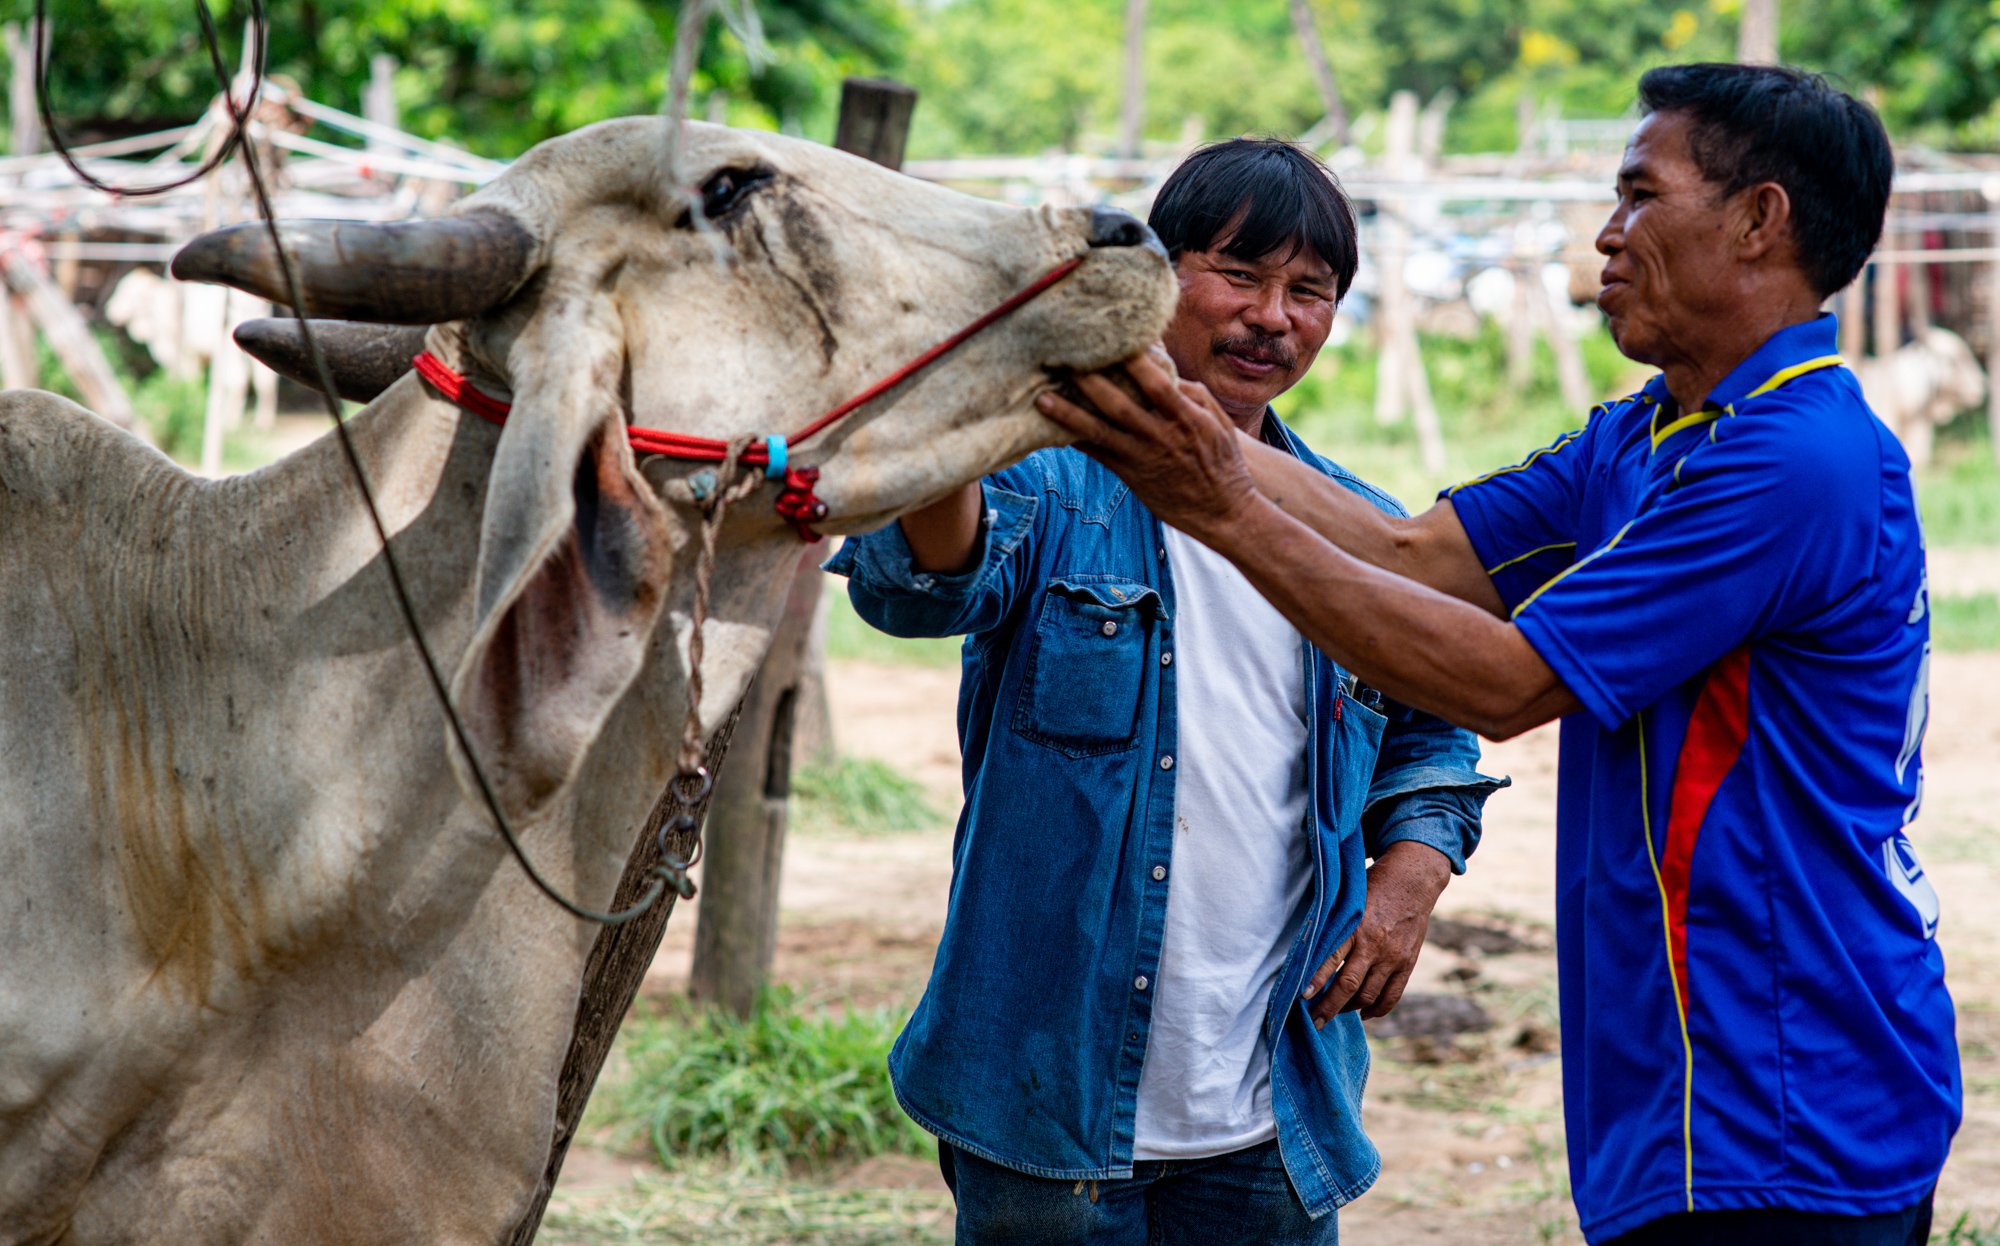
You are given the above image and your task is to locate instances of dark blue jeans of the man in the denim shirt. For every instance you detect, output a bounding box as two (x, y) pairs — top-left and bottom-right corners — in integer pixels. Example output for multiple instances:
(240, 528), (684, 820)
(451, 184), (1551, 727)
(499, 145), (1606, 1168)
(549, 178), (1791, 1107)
(938, 1142), (1340, 1246)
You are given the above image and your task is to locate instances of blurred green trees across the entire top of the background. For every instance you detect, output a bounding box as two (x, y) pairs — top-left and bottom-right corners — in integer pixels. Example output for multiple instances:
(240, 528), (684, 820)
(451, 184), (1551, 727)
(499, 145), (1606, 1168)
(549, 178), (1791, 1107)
(15, 0), (2000, 158)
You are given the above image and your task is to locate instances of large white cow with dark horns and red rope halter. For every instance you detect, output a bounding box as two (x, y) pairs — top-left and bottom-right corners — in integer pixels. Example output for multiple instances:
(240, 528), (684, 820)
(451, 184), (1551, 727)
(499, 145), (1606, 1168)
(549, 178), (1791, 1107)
(0, 118), (1174, 1246)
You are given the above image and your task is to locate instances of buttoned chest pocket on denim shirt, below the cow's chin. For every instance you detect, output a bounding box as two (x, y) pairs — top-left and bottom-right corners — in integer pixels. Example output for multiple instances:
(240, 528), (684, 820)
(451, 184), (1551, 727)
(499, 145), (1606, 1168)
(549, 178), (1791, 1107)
(1014, 576), (1162, 758)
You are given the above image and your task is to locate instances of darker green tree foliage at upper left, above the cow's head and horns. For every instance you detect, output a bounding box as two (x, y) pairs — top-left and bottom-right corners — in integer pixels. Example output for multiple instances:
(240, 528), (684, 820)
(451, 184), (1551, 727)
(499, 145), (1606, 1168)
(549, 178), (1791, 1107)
(0, 0), (908, 158)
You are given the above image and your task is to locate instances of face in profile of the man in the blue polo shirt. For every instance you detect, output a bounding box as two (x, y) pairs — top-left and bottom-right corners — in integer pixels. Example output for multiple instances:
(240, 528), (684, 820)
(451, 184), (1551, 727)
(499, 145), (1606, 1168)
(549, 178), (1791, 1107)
(1598, 112), (1738, 366)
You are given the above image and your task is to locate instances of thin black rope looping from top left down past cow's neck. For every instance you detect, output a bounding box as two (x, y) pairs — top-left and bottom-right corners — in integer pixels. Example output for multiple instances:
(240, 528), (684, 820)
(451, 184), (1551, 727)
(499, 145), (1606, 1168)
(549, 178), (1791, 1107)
(34, 0), (680, 926)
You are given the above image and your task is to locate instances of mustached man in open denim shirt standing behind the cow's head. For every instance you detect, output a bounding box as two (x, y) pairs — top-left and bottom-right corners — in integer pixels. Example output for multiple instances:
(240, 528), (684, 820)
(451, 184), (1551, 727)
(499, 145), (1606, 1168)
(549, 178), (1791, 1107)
(828, 140), (1496, 1246)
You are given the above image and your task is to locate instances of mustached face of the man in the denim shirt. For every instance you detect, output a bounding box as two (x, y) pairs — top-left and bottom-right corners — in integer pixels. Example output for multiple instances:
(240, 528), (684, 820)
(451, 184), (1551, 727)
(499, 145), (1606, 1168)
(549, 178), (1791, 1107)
(1162, 238), (1338, 430)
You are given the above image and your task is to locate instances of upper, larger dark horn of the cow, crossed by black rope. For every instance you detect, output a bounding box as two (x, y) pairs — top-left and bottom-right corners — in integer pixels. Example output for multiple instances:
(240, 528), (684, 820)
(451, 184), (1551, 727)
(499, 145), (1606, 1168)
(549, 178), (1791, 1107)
(174, 208), (536, 324)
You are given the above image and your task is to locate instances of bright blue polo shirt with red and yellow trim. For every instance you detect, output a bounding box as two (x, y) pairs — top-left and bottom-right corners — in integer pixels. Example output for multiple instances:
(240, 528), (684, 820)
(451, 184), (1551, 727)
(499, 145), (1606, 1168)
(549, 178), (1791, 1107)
(1446, 316), (1960, 1242)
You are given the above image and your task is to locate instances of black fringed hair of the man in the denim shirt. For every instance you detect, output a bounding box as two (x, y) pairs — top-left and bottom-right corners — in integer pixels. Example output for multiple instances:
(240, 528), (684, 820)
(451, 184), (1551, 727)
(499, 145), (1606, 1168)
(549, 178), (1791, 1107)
(1146, 138), (1360, 302)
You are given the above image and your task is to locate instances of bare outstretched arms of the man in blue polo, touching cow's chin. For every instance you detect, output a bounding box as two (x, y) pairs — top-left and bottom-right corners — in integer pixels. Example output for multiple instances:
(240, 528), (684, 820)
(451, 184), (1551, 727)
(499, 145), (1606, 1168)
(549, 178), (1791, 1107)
(1040, 358), (1582, 740)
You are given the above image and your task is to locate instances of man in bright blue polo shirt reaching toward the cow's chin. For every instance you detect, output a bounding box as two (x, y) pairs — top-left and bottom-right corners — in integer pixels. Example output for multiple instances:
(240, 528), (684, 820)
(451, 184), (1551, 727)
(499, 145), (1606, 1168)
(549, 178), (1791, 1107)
(1048, 66), (1960, 1246)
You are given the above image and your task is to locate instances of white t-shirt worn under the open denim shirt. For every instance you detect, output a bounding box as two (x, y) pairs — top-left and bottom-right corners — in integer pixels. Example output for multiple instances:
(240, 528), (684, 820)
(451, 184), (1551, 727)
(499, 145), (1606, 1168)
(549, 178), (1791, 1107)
(1132, 528), (1312, 1160)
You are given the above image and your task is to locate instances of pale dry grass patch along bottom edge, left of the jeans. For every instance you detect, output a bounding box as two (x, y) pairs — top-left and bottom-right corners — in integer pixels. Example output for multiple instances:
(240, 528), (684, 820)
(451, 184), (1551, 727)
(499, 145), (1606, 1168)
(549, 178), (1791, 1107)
(536, 1164), (952, 1246)
